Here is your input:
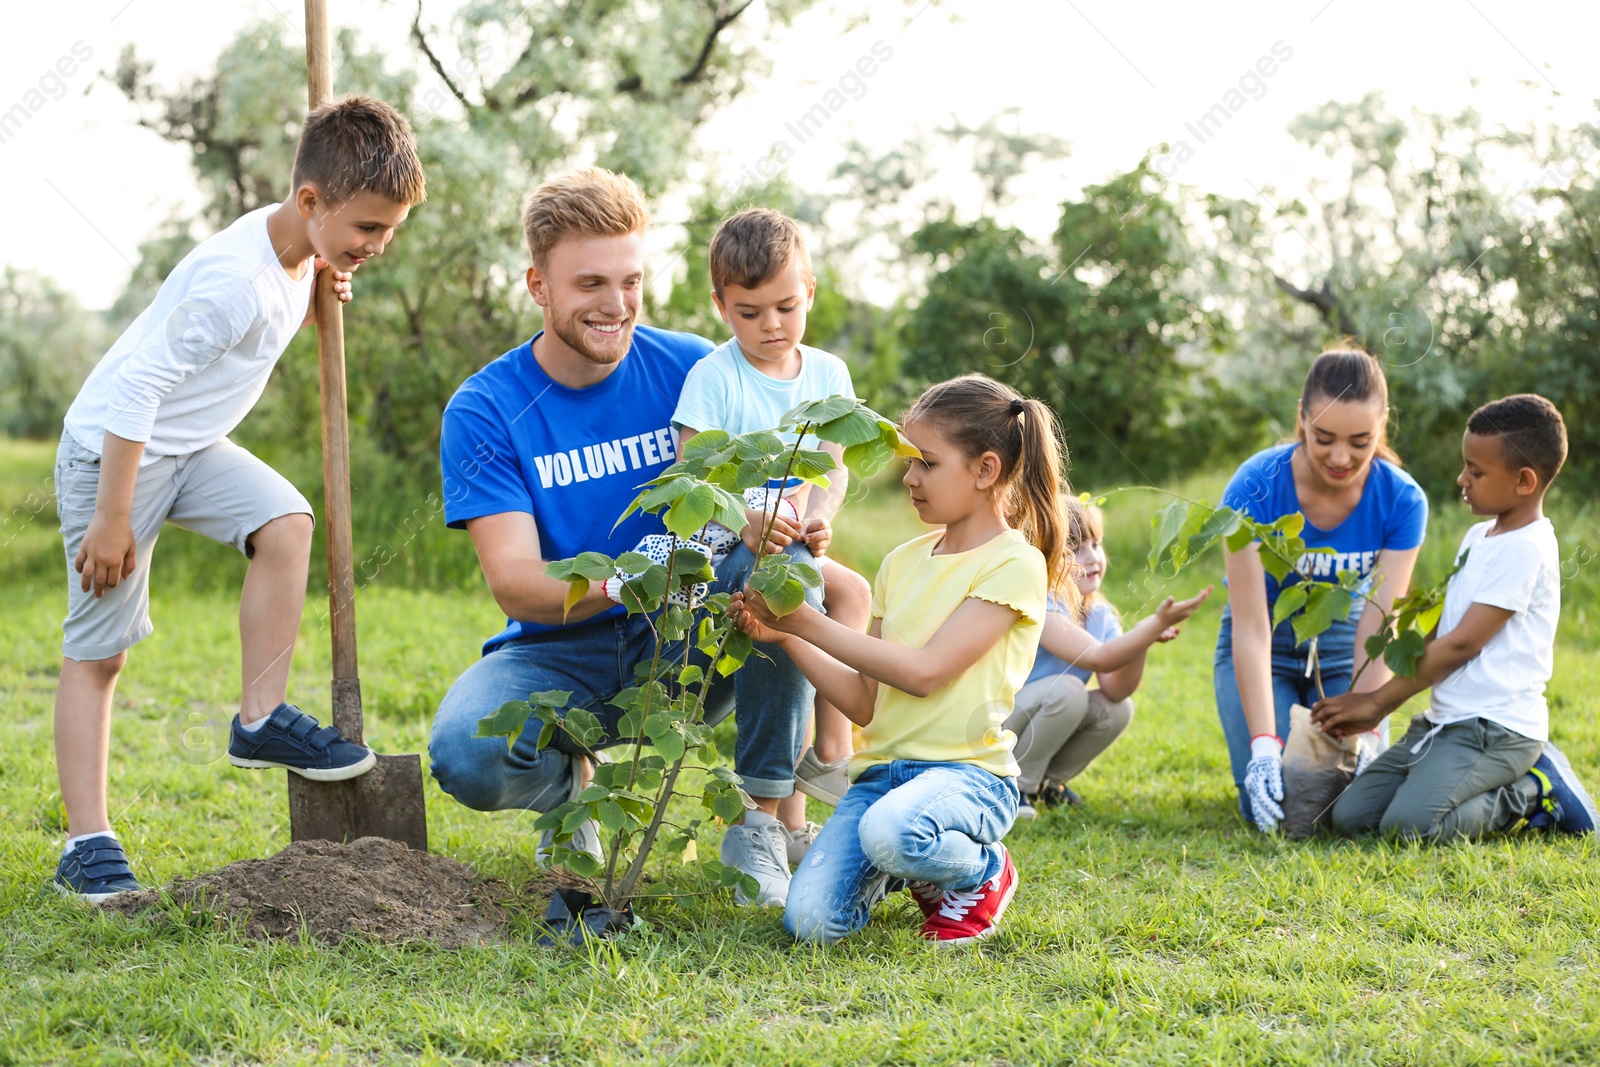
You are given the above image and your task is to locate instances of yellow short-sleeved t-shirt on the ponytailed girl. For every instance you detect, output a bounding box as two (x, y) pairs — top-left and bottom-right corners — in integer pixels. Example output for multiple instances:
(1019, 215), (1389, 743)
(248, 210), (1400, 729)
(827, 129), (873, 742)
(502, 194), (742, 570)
(850, 530), (1048, 781)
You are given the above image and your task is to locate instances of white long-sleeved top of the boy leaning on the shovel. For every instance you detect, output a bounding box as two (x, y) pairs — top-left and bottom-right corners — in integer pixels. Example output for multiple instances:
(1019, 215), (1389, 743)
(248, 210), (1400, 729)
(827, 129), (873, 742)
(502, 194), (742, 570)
(66, 206), (315, 464)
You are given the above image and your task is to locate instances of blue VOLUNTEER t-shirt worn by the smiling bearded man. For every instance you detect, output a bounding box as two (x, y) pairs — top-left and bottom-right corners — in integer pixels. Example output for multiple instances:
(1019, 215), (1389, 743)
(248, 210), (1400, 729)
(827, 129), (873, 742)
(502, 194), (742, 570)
(438, 326), (712, 654)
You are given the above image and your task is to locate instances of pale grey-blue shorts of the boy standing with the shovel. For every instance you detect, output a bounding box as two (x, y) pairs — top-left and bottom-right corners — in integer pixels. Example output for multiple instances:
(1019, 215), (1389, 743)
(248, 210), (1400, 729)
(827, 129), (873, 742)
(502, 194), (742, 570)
(56, 434), (314, 661)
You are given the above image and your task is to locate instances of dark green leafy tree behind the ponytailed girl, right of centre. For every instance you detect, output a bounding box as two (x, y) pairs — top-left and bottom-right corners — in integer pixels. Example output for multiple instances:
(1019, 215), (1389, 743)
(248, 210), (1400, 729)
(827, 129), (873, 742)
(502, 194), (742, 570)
(907, 163), (1214, 482)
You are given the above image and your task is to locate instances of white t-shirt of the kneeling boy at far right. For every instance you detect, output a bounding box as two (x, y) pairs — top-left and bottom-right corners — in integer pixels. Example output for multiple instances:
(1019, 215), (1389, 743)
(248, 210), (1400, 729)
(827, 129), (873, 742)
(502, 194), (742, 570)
(1427, 518), (1562, 741)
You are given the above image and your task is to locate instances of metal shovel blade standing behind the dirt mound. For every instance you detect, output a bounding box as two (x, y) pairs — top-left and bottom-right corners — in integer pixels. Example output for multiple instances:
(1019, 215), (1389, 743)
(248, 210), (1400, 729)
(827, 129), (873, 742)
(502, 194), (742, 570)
(290, 752), (427, 853)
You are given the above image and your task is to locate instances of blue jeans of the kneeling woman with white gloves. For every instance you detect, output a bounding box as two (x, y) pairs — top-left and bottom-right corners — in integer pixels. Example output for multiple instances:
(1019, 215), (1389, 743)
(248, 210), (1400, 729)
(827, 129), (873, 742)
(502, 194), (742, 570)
(1211, 608), (1360, 824)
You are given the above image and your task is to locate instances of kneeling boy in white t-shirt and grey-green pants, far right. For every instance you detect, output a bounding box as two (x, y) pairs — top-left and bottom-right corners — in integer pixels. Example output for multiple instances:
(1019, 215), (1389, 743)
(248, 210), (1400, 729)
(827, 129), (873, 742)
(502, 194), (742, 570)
(1312, 394), (1595, 840)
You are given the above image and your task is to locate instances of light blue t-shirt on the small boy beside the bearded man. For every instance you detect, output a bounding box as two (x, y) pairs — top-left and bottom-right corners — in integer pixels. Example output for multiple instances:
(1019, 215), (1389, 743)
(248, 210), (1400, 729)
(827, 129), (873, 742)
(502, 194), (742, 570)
(672, 339), (856, 483)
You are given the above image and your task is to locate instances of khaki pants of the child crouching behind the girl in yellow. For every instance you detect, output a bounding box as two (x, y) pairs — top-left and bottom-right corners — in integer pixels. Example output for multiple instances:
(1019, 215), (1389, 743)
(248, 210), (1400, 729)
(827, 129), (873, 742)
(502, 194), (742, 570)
(1005, 673), (1133, 797)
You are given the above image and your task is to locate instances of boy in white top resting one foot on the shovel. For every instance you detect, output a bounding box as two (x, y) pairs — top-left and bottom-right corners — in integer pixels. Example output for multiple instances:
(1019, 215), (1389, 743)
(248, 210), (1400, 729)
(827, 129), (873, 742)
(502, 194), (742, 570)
(53, 96), (426, 901)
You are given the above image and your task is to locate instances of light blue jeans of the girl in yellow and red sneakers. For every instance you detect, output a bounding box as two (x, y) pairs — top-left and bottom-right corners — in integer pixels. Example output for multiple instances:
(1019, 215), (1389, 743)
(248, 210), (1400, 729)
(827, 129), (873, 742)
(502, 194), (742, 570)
(784, 760), (1019, 944)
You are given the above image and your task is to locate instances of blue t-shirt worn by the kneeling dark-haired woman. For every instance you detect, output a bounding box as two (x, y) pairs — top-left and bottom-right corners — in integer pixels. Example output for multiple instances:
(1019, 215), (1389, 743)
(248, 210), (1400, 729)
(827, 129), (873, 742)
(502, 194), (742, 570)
(1222, 442), (1427, 605)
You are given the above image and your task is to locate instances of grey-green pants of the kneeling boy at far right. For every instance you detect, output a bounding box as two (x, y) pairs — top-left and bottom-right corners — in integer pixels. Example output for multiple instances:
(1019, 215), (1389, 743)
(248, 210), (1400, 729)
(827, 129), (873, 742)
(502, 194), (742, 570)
(1333, 715), (1544, 841)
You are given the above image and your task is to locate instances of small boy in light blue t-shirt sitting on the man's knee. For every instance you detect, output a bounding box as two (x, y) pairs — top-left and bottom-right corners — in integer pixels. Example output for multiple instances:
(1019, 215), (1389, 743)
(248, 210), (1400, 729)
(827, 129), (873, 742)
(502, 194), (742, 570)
(672, 208), (872, 875)
